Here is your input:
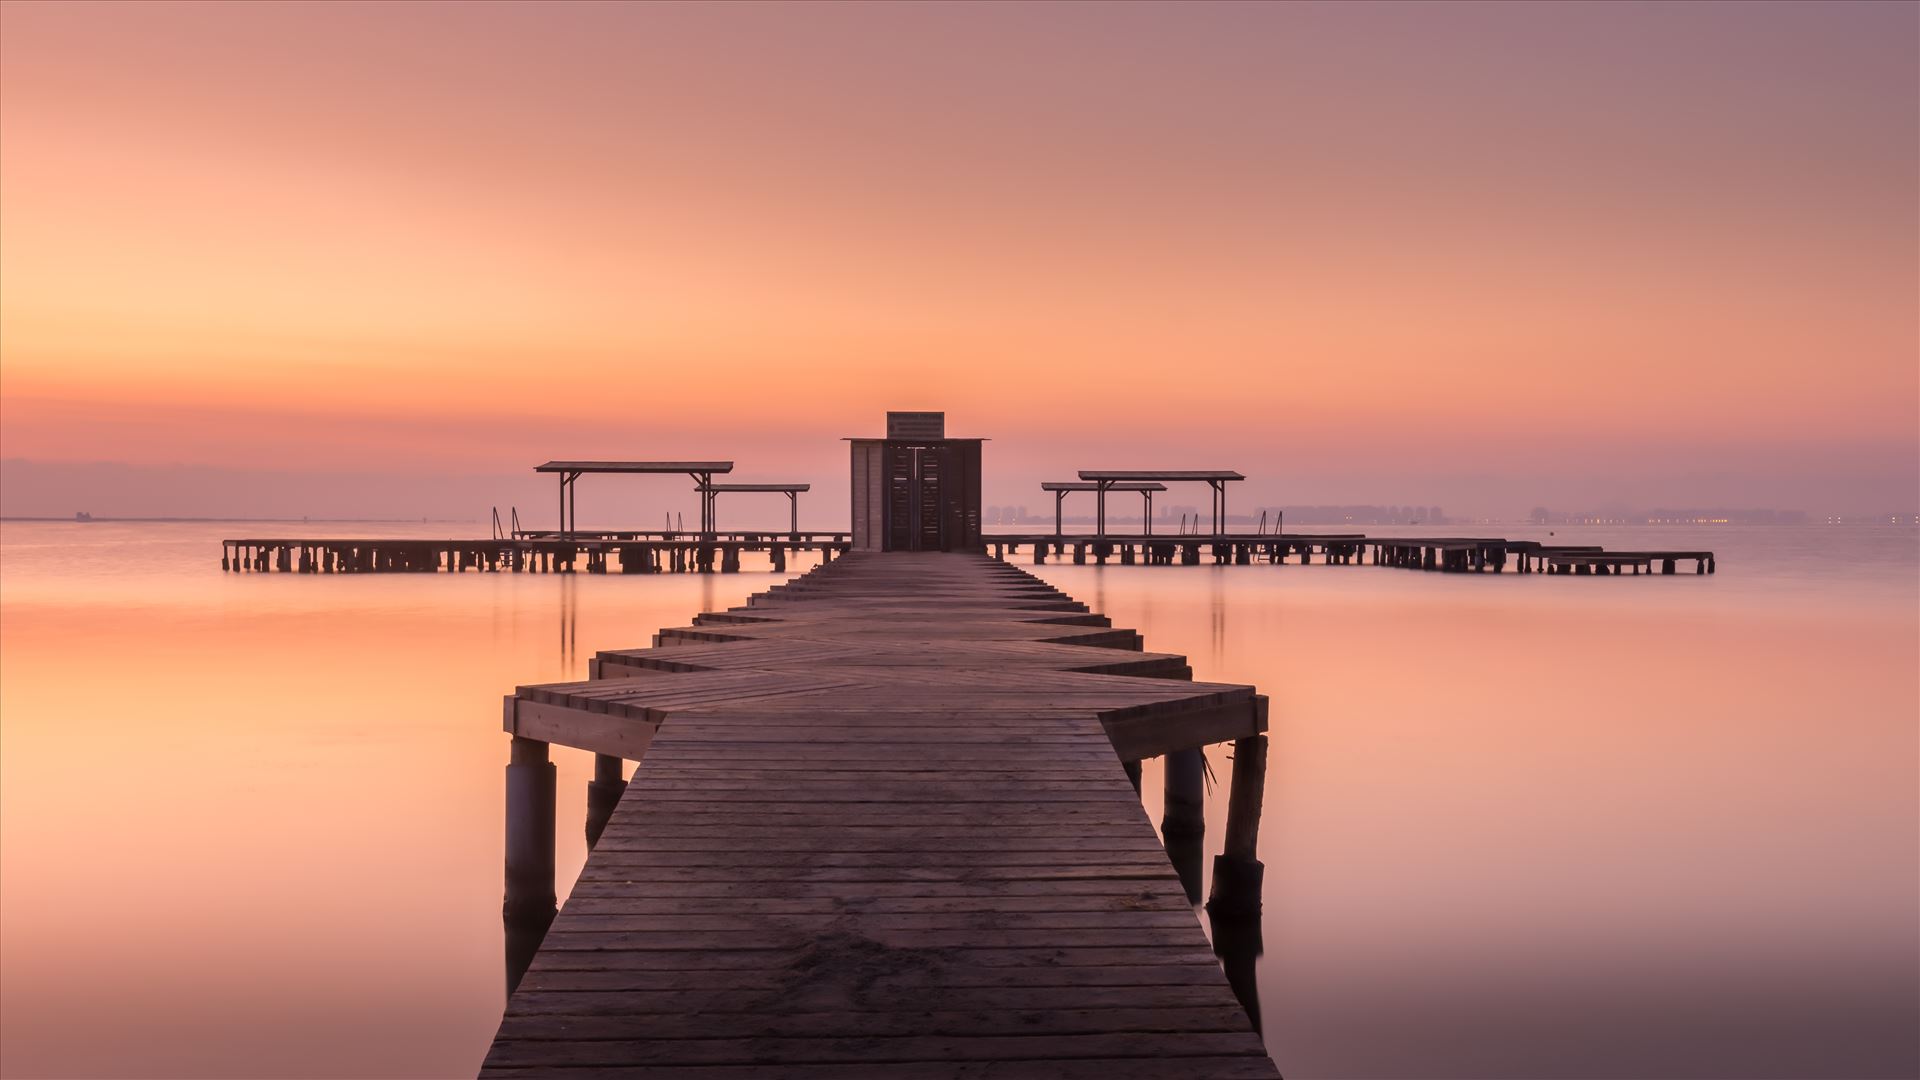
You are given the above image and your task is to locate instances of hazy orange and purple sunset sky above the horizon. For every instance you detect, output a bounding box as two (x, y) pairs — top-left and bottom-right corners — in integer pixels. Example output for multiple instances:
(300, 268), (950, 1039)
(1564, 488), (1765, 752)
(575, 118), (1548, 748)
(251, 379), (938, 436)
(0, 4), (1920, 525)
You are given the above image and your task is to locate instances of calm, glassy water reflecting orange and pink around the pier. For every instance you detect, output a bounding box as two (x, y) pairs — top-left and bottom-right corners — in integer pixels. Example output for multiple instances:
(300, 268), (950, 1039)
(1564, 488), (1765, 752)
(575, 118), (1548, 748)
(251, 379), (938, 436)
(0, 523), (1920, 1080)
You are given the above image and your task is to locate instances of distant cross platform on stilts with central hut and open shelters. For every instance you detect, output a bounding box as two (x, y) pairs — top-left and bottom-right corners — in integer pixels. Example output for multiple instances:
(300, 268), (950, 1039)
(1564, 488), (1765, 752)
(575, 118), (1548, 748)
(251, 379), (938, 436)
(221, 428), (1715, 577)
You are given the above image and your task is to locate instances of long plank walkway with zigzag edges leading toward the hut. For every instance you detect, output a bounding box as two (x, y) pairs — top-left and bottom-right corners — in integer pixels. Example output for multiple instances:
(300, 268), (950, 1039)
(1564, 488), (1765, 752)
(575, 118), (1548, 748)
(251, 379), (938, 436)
(482, 552), (1279, 1080)
